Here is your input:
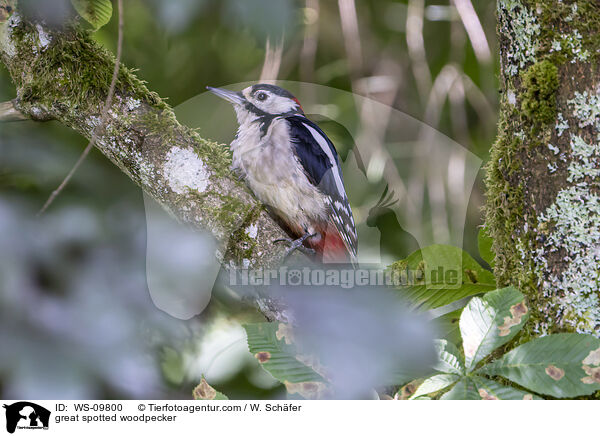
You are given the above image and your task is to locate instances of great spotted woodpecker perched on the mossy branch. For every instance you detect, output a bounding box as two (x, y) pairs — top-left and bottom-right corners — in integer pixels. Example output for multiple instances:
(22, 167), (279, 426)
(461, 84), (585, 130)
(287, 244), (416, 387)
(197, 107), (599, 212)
(207, 84), (358, 264)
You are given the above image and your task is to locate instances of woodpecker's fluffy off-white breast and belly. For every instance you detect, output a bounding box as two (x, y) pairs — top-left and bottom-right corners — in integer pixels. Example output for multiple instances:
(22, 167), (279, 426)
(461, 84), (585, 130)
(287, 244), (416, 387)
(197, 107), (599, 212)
(231, 118), (327, 231)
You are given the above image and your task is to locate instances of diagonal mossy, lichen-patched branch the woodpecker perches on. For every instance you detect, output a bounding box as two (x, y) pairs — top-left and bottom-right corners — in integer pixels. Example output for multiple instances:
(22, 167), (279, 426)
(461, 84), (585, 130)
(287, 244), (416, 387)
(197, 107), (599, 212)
(0, 12), (294, 318)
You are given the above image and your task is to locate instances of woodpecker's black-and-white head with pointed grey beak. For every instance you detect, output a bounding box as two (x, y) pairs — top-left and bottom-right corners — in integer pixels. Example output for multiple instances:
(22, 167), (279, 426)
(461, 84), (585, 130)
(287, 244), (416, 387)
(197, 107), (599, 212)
(207, 83), (304, 124)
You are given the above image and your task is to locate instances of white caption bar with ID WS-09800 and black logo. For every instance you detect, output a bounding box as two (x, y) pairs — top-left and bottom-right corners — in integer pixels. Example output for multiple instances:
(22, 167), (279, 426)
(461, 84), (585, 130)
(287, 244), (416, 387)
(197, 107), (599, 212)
(0, 400), (598, 436)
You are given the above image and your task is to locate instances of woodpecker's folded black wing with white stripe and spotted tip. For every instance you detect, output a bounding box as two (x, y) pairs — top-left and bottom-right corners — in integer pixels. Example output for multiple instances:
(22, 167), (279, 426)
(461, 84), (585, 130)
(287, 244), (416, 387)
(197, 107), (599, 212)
(286, 115), (358, 261)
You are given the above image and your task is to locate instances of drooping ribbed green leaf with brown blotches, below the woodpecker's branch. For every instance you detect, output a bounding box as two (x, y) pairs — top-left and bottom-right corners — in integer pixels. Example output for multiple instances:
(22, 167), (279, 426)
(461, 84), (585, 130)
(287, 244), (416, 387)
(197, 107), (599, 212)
(243, 322), (327, 398)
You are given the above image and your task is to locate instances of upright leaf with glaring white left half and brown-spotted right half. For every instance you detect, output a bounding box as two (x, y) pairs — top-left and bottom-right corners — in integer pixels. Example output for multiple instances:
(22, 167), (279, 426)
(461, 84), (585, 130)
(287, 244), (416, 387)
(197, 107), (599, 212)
(459, 287), (529, 372)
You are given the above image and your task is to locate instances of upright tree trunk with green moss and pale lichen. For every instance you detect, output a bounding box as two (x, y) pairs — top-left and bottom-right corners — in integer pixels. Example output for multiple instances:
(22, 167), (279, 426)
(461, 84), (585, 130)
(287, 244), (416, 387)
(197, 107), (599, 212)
(485, 0), (600, 336)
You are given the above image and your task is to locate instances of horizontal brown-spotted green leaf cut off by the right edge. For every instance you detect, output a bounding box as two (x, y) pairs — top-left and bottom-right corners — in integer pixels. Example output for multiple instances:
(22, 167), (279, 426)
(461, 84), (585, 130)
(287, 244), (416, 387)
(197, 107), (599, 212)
(477, 333), (600, 398)
